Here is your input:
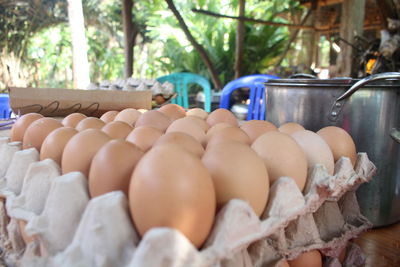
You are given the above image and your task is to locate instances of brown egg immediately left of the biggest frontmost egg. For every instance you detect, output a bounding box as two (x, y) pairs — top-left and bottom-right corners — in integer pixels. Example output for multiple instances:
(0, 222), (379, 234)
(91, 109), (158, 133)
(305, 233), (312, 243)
(89, 139), (143, 198)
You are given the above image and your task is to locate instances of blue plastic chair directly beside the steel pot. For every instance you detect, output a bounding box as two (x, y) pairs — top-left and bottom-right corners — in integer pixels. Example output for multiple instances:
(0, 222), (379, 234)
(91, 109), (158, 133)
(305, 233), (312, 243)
(219, 74), (279, 120)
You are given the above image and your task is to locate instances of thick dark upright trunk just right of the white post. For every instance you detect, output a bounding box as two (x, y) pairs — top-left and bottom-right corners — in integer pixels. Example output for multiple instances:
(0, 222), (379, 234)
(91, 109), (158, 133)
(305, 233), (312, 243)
(122, 0), (138, 79)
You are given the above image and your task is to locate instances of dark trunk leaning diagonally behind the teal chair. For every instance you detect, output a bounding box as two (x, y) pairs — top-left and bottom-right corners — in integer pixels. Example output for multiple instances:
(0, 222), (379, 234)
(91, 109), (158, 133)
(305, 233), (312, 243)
(165, 0), (222, 89)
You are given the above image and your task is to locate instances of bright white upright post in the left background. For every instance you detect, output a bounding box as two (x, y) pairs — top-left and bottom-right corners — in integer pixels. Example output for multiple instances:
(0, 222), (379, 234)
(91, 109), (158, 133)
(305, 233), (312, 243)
(68, 0), (90, 89)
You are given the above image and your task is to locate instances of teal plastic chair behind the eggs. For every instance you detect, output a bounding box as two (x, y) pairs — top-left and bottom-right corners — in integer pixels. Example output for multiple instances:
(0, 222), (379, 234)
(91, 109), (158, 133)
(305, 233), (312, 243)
(157, 72), (211, 112)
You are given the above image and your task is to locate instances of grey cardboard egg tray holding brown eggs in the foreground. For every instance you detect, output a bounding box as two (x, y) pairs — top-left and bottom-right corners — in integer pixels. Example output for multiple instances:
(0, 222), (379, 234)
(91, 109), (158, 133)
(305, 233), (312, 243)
(0, 137), (376, 267)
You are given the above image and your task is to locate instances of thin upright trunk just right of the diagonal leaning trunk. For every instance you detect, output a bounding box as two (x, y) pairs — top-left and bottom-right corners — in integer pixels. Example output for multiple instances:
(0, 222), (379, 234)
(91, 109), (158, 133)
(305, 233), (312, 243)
(235, 0), (246, 79)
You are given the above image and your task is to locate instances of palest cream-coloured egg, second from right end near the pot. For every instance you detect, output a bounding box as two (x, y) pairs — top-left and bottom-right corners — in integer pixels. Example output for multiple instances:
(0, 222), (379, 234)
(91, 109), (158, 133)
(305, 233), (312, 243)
(292, 130), (335, 175)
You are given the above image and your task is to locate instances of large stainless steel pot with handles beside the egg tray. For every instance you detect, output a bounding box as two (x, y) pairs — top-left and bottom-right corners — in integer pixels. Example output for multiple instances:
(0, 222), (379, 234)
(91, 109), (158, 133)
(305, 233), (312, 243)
(266, 72), (400, 226)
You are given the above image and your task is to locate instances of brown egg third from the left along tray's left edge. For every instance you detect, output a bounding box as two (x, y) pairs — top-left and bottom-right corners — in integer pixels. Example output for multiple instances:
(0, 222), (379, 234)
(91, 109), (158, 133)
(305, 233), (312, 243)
(40, 127), (78, 165)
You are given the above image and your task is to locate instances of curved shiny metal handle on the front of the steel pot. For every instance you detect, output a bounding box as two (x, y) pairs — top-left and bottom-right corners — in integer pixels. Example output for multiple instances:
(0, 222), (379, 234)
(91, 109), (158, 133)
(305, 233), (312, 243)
(329, 72), (400, 122)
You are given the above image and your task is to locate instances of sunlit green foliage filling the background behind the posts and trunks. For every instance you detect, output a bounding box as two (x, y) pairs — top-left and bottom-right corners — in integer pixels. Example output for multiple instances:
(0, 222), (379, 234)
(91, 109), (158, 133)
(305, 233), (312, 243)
(0, 0), (299, 87)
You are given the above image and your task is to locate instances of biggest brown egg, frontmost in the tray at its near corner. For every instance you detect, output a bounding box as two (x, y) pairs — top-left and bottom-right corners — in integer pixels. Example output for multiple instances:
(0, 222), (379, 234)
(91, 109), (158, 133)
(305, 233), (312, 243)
(129, 144), (216, 248)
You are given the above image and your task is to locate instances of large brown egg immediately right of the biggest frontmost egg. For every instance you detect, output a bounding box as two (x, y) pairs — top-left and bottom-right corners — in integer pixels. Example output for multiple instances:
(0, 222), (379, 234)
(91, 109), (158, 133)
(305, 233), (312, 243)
(202, 141), (269, 216)
